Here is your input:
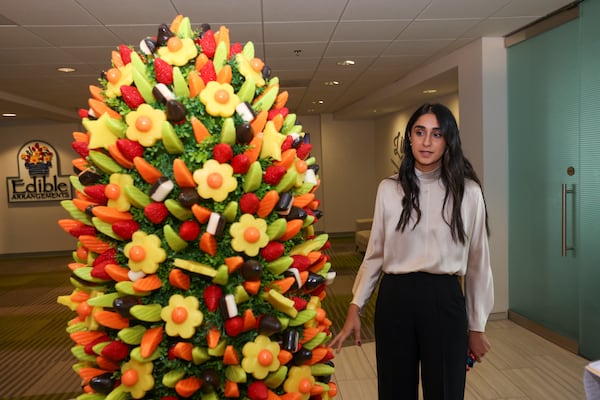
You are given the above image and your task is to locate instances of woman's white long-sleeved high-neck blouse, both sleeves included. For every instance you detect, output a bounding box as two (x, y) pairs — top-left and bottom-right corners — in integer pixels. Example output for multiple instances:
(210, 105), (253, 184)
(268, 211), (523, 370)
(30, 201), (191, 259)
(352, 169), (494, 332)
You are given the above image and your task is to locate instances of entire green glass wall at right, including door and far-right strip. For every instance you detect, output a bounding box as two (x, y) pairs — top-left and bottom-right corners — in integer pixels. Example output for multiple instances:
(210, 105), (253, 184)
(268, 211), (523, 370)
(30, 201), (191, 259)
(507, 1), (600, 359)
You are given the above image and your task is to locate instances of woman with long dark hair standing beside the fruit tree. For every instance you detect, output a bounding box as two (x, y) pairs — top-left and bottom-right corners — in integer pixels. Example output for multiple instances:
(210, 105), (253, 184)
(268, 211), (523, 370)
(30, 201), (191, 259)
(331, 104), (494, 400)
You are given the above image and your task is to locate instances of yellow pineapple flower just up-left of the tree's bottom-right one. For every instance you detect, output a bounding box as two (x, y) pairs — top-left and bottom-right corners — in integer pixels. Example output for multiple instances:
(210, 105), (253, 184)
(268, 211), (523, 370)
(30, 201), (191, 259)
(242, 335), (282, 379)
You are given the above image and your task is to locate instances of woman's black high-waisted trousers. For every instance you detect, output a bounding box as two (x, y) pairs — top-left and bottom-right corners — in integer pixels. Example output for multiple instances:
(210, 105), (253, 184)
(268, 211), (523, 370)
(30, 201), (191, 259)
(375, 272), (467, 400)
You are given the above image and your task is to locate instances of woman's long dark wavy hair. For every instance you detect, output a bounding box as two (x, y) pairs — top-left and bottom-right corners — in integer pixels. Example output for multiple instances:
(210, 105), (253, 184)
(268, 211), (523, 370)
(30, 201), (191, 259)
(396, 104), (489, 244)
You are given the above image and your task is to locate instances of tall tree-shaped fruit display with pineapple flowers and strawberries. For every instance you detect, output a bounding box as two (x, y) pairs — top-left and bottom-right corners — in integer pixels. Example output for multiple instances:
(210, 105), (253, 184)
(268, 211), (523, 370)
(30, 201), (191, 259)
(58, 15), (337, 400)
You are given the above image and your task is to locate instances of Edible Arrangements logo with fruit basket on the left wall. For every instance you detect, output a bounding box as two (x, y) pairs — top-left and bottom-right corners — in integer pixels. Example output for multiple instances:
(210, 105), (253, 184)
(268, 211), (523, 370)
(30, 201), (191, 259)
(6, 140), (73, 203)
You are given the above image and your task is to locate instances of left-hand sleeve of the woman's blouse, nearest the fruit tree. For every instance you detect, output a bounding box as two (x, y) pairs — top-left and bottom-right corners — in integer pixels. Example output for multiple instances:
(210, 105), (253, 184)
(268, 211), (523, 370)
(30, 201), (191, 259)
(352, 181), (385, 310)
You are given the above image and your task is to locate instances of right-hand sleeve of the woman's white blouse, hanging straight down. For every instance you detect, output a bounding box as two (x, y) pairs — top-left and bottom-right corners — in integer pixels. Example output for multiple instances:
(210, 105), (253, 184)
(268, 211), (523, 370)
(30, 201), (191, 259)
(463, 184), (494, 332)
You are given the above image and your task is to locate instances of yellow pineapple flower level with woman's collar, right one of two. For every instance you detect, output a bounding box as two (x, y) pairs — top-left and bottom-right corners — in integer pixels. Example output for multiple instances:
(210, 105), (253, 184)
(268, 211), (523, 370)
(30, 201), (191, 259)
(194, 160), (237, 201)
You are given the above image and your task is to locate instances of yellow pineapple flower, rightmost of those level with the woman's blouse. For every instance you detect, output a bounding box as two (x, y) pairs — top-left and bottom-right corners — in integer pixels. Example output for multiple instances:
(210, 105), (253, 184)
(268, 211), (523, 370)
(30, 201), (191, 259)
(229, 214), (269, 257)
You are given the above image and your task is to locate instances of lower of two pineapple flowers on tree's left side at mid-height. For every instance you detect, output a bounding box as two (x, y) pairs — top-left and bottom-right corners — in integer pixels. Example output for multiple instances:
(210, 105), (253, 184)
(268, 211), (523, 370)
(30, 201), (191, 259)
(123, 231), (167, 274)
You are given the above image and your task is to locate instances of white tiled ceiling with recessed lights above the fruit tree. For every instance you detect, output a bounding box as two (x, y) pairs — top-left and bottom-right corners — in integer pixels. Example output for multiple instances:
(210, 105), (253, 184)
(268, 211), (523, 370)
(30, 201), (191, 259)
(0, 0), (573, 124)
